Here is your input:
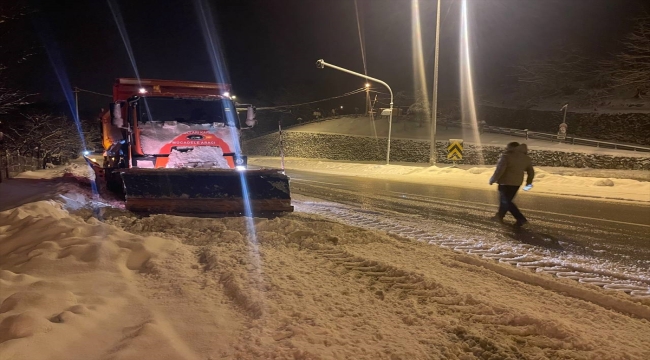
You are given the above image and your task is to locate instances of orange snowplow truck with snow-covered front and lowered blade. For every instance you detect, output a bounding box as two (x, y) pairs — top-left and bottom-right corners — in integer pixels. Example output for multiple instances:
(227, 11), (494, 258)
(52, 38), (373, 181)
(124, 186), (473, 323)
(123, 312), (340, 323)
(85, 78), (293, 215)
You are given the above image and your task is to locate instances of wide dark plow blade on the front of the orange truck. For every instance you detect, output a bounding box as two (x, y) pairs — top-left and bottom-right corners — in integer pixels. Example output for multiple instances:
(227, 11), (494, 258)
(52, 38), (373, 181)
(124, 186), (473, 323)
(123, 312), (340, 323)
(120, 168), (293, 215)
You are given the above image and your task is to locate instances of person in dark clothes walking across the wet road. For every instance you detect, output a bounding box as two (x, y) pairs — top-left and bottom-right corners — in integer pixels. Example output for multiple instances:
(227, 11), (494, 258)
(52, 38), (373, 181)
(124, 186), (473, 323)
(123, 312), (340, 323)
(490, 142), (535, 227)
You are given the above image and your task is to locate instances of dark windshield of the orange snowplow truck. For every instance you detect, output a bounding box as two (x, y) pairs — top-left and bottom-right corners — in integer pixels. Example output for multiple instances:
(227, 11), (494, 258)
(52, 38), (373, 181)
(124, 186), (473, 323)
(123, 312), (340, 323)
(138, 97), (239, 127)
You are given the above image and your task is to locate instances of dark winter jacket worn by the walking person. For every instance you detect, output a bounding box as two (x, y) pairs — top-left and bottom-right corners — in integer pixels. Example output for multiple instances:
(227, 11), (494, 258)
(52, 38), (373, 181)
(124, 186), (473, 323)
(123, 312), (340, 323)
(490, 144), (535, 186)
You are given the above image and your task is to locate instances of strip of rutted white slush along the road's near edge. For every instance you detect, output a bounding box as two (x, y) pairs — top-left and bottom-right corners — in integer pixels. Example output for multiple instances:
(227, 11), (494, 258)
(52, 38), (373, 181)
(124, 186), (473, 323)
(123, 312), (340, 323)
(295, 198), (650, 298)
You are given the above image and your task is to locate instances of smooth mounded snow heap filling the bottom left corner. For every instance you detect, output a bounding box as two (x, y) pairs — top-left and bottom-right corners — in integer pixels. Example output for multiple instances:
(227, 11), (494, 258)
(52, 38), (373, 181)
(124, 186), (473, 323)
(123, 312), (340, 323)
(0, 202), (186, 359)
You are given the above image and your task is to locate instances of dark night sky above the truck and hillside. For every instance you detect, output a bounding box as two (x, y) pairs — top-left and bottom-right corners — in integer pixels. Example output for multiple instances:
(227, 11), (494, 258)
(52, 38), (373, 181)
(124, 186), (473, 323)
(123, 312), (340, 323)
(25, 0), (650, 112)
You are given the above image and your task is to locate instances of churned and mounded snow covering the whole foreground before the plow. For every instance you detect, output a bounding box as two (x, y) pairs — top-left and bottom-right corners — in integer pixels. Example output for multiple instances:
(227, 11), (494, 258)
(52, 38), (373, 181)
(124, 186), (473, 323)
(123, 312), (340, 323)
(0, 169), (650, 360)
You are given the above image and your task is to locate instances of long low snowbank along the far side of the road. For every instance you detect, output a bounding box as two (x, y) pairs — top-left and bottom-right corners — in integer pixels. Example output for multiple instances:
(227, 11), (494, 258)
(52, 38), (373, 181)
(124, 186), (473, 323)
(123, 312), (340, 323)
(248, 157), (650, 202)
